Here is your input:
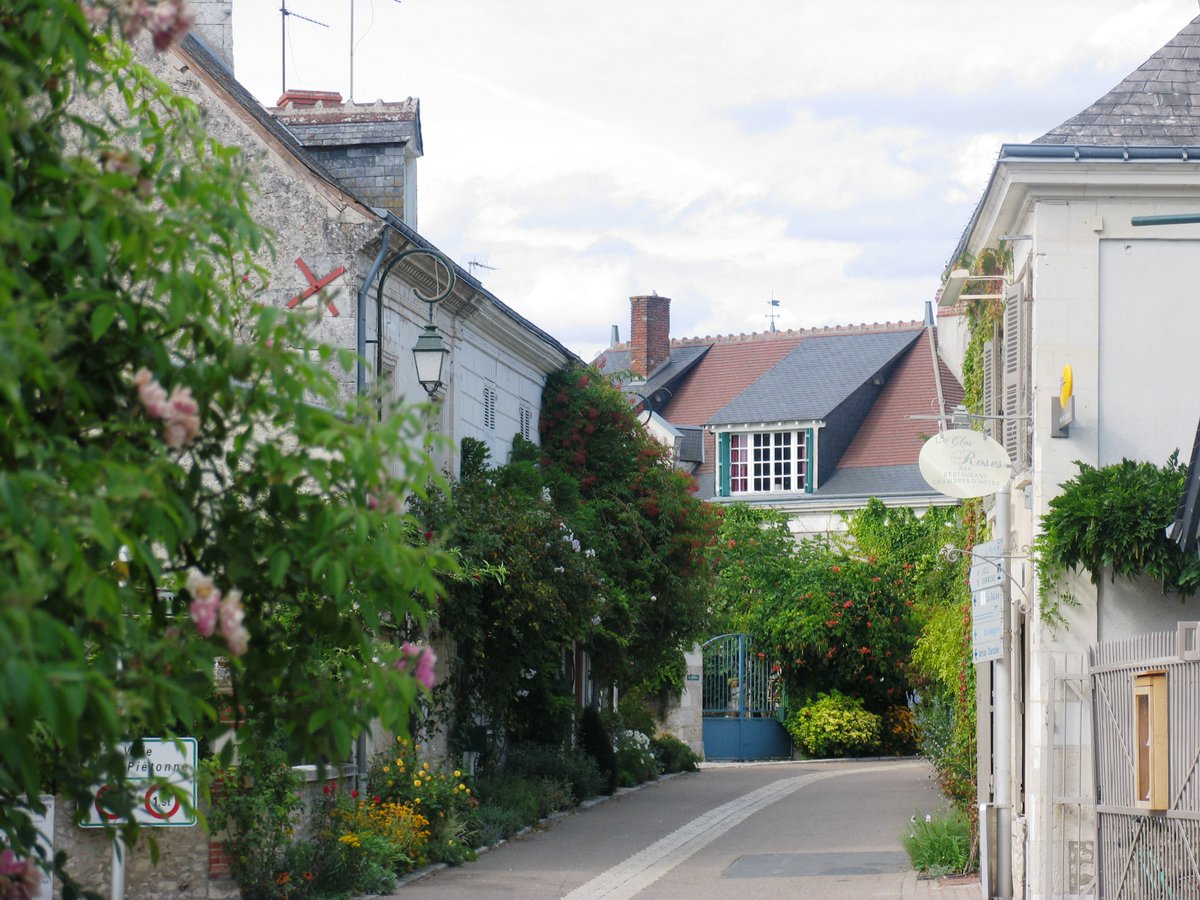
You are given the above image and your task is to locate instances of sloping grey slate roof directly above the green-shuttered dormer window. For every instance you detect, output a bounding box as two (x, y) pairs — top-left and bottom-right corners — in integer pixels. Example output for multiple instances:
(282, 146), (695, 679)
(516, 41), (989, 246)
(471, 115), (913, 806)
(708, 330), (922, 425)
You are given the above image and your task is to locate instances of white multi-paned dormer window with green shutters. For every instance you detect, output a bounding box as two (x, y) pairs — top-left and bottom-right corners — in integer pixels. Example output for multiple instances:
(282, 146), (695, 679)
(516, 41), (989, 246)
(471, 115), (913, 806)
(720, 428), (811, 497)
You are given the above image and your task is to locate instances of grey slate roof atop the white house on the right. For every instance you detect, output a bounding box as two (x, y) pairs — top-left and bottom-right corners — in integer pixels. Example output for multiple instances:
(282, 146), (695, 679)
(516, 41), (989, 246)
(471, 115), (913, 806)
(1033, 17), (1200, 146)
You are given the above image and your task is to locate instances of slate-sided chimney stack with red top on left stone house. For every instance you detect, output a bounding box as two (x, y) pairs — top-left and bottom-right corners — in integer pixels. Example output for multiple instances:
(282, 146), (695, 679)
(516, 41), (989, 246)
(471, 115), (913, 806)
(268, 90), (424, 228)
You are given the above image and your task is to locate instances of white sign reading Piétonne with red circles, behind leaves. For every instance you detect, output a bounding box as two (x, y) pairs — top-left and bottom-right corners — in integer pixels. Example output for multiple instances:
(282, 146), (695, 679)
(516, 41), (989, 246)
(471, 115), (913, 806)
(79, 738), (197, 828)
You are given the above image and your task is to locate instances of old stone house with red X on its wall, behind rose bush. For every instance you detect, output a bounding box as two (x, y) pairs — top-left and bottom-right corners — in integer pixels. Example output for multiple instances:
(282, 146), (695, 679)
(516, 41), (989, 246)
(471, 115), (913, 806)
(53, 0), (576, 900)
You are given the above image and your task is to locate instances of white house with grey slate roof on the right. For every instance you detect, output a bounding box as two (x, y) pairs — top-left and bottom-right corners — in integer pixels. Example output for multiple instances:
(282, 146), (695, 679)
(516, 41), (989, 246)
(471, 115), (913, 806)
(942, 19), (1200, 898)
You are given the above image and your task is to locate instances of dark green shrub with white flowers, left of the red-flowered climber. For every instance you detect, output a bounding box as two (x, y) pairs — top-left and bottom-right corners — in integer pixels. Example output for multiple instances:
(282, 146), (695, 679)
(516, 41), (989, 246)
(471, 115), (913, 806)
(415, 439), (602, 744)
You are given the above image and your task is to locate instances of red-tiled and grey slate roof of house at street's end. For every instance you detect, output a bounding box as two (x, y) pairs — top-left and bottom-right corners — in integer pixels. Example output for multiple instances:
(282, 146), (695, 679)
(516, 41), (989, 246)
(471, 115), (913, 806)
(596, 322), (962, 506)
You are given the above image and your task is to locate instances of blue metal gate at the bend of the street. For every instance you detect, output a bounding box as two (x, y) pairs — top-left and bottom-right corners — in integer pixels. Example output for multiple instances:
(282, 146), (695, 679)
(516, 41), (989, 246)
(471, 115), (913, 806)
(702, 635), (792, 760)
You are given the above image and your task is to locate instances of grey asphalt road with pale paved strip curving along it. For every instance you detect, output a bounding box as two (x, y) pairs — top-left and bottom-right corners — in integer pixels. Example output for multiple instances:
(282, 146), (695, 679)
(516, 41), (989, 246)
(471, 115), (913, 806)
(395, 760), (946, 900)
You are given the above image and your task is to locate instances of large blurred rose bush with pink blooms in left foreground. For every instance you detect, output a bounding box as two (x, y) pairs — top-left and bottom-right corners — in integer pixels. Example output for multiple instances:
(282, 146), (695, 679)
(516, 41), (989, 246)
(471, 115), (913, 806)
(0, 0), (451, 873)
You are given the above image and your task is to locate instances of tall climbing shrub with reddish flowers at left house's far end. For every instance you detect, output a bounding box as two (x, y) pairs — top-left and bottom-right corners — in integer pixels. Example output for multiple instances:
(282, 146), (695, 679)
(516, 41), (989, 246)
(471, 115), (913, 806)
(539, 366), (719, 691)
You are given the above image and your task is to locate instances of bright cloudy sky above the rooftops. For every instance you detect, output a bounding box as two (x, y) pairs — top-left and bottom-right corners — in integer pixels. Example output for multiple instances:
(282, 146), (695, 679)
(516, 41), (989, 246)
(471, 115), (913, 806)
(234, 0), (1200, 359)
